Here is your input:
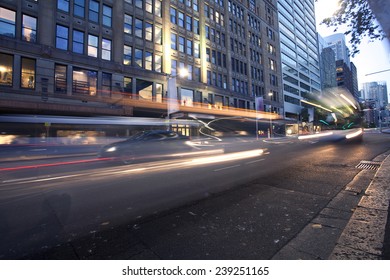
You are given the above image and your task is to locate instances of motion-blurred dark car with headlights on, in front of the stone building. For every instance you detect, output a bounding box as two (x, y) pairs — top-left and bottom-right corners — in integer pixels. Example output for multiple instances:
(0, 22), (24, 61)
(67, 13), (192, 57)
(98, 130), (193, 163)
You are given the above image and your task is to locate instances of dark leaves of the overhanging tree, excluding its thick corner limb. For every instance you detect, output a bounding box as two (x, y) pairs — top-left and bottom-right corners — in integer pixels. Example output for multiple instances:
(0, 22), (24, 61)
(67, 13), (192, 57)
(316, 0), (386, 56)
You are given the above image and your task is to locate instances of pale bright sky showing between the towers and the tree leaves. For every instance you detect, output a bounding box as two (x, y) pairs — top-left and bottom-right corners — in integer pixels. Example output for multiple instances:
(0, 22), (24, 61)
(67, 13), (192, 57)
(315, 0), (390, 96)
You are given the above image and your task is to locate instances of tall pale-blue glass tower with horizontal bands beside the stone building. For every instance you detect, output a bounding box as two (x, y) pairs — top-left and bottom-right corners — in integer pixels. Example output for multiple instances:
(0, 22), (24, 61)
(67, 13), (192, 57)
(278, 0), (321, 119)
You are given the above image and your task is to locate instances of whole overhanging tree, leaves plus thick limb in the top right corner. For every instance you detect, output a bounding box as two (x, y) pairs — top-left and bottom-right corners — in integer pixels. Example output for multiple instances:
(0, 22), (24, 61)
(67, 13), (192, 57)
(316, 0), (390, 56)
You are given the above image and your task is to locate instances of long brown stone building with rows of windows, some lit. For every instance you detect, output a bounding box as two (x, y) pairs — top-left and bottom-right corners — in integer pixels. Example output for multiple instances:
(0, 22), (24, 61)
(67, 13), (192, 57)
(0, 0), (284, 116)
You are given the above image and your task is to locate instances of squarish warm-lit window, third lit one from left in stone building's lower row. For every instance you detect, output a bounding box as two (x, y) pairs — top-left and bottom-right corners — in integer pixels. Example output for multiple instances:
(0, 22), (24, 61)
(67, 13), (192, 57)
(72, 67), (97, 96)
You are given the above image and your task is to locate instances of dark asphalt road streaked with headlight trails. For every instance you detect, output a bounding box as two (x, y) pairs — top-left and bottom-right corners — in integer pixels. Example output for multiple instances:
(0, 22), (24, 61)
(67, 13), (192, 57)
(0, 133), (390, 259)
